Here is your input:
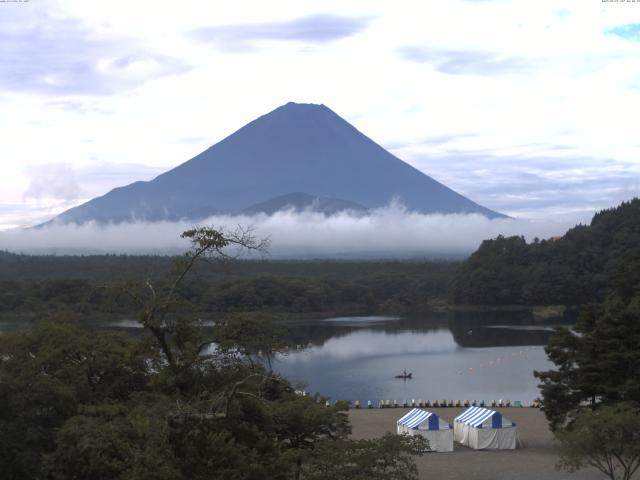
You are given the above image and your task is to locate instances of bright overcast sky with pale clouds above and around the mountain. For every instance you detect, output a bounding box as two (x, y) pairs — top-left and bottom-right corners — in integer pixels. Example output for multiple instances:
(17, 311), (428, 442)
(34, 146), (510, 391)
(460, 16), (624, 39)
(0, 0), (640, 229)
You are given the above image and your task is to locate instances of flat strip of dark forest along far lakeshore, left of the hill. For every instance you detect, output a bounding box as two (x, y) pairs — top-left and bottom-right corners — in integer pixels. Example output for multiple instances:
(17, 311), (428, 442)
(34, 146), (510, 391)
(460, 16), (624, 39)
(0, 253), (456, 318)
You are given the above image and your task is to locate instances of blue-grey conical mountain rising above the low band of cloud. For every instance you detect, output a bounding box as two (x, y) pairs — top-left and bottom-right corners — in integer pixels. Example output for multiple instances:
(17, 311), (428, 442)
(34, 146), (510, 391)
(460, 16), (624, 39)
(47, 103), (503, 223)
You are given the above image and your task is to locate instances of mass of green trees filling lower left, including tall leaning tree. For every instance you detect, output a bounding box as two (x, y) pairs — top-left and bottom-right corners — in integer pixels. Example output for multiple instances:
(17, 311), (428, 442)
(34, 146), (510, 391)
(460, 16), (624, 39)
(0, 228), (424, 480)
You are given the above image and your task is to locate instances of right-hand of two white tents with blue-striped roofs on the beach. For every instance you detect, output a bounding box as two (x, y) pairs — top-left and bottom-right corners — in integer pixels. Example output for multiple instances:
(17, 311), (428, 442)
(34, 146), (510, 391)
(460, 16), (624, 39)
(453, 407), (521, 450)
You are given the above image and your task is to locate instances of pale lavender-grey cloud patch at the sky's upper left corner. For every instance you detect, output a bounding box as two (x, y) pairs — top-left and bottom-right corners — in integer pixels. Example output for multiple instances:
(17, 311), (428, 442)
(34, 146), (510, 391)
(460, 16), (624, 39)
(0, 7), (189, 95)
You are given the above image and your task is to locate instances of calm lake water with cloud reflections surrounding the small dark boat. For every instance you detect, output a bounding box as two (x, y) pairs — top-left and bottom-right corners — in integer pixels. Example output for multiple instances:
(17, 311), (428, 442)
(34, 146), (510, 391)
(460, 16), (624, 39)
(274, 312), (552, 404)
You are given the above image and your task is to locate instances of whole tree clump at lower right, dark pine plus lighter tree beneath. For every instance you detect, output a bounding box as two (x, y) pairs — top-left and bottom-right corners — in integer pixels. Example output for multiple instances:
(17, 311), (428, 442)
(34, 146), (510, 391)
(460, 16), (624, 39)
(535, 248), (640, 480)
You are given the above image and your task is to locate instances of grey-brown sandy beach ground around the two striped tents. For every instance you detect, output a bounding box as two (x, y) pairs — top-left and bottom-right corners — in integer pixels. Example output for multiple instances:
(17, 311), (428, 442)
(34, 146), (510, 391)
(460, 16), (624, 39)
(349, 408), (606, 480)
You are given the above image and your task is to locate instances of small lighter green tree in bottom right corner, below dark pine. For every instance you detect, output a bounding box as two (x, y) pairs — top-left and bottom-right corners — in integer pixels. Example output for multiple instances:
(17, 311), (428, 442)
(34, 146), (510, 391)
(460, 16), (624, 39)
(557, 404), (640, 480)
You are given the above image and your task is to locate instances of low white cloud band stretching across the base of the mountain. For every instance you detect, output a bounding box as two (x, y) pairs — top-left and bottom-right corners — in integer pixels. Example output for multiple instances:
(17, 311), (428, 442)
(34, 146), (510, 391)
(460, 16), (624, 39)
(0, 204), (574, 258)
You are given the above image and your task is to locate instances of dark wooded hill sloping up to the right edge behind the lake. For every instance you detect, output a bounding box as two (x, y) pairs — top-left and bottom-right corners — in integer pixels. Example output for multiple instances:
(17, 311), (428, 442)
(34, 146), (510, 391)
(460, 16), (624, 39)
(451, 198), (640, 305)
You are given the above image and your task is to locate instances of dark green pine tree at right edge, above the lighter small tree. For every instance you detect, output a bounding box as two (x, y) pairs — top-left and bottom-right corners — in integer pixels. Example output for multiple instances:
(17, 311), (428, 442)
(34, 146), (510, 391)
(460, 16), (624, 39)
(535, 276), (640, 430)
